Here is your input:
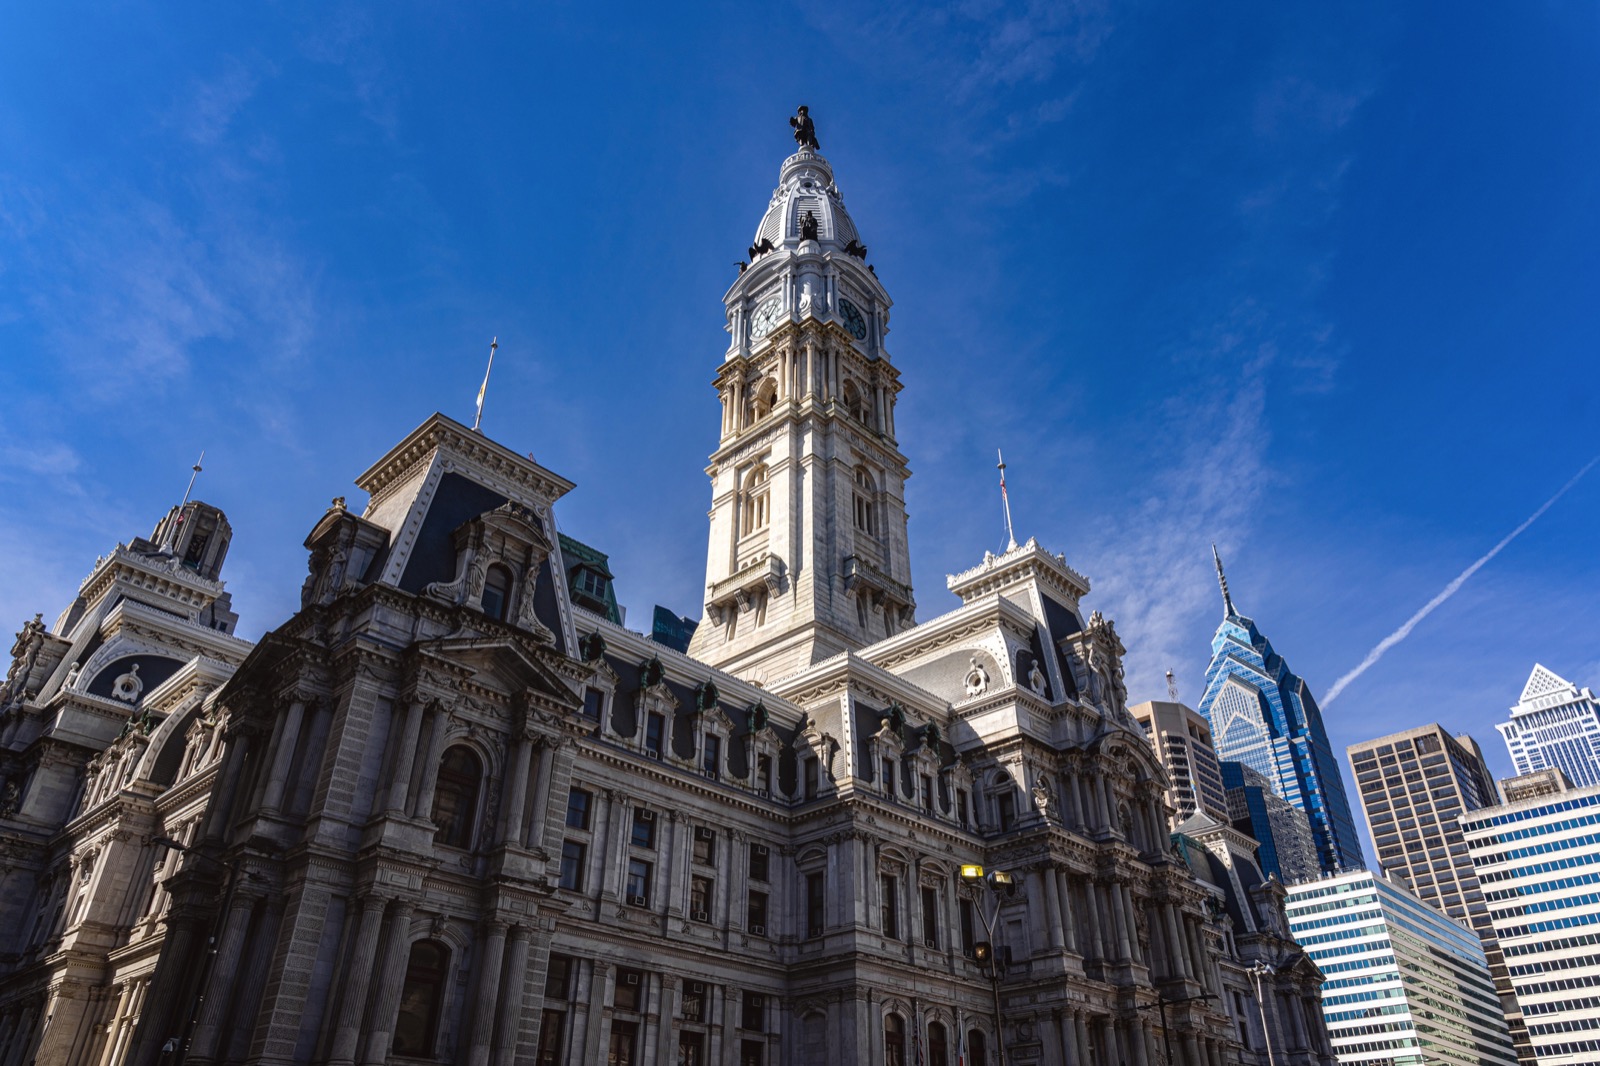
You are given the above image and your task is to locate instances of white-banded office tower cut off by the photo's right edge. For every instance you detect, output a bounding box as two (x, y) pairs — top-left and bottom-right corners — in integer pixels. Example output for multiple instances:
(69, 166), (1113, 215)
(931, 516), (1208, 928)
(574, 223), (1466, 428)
(1461, 770), (1600, 1066)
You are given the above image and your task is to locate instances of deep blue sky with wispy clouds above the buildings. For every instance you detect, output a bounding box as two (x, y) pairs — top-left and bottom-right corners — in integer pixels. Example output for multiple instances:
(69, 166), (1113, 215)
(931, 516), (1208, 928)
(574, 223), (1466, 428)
(0, 0), (1600, 797)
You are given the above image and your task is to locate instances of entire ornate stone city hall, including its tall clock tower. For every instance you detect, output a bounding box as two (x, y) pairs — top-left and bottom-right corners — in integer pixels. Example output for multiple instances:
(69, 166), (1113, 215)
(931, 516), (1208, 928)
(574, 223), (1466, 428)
(0, 109), (1333, 1066)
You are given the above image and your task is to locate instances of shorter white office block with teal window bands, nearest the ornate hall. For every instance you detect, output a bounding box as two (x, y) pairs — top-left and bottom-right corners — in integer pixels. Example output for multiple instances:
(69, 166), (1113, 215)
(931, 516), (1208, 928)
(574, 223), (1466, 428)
(1288, 871), (1517, 1066)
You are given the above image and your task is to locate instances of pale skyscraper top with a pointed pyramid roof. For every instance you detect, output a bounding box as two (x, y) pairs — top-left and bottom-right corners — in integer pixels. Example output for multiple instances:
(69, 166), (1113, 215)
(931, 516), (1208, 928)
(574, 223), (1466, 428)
(1494, 663), (1600, 787)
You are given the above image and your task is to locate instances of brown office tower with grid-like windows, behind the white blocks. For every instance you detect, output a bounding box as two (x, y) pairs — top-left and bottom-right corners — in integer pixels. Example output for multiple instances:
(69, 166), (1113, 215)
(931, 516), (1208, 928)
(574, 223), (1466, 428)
(1347, 723), (1533, 1063)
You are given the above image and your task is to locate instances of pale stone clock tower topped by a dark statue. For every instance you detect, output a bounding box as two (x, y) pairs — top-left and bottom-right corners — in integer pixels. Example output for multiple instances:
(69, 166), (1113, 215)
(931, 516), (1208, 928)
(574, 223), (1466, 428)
(690, 109), (915, 683)
